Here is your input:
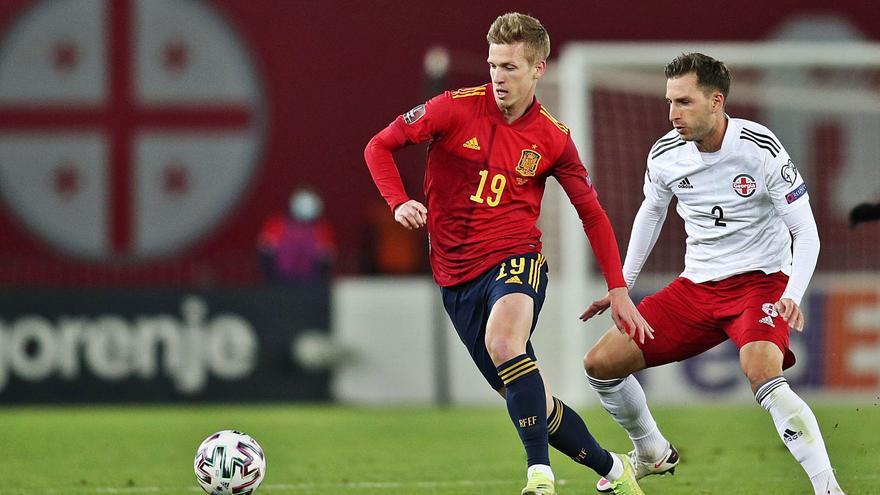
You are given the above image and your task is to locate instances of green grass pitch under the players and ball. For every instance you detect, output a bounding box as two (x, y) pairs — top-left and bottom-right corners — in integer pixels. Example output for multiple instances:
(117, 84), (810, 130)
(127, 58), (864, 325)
(0, 404), (880, 495)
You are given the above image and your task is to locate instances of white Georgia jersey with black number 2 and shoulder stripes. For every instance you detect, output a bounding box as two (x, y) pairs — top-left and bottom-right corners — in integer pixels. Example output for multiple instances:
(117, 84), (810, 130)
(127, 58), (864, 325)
(644, 118), (809, 283)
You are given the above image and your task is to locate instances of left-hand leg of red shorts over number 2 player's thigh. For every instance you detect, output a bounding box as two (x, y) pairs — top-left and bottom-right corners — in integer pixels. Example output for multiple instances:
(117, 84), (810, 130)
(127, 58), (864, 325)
(633, 278), (727, 368)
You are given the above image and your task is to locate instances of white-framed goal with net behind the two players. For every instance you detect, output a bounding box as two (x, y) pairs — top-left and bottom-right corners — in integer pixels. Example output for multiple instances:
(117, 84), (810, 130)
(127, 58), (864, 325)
(539, 42), (880, 404)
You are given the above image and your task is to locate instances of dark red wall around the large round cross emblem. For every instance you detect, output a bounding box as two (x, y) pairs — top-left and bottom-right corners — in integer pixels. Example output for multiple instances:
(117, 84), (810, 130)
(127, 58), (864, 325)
(0, 0), (880, 285)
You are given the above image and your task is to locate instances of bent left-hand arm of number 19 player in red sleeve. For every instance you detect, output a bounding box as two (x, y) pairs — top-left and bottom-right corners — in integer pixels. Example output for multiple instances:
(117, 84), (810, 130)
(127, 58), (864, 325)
(364, 95), (448, 229)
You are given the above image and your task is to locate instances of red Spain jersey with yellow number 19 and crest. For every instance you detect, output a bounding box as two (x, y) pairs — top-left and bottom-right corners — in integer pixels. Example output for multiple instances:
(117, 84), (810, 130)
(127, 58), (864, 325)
(367, 84), (622, 286)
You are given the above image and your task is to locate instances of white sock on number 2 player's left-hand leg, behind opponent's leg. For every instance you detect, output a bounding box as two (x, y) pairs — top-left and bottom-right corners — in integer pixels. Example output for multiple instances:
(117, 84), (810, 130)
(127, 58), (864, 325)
(587, 375), (669, 462)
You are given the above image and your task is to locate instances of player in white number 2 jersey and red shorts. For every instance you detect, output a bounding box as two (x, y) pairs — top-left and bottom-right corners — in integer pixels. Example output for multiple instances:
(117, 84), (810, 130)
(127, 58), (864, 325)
(581, 53), (843, 494)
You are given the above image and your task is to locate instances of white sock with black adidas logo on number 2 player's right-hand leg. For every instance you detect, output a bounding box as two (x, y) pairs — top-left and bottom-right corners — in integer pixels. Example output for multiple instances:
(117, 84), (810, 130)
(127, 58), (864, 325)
(755, 376), (840, 493)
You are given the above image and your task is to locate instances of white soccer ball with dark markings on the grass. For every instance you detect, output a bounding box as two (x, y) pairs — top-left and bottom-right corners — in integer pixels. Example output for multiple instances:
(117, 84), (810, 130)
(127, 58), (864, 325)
(193, 430), (266, 495)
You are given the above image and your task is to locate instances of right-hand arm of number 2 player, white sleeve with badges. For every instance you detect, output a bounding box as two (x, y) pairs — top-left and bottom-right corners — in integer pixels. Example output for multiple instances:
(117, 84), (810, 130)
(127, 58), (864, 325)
(764, 149), (819, 332)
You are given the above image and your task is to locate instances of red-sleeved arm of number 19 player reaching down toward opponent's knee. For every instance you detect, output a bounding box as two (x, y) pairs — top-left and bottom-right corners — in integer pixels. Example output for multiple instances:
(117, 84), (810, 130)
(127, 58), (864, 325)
(553, 137), (654, 342)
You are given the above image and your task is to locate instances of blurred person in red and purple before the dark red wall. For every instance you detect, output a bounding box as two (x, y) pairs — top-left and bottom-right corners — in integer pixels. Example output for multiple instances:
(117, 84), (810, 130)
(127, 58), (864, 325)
(257, 187), (336, 285)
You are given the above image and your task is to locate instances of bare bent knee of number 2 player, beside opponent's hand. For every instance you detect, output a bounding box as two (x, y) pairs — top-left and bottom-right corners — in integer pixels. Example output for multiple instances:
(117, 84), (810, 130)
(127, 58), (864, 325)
(584, 327), (645, 380)
